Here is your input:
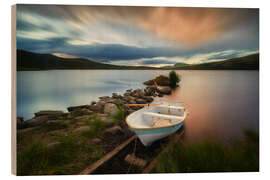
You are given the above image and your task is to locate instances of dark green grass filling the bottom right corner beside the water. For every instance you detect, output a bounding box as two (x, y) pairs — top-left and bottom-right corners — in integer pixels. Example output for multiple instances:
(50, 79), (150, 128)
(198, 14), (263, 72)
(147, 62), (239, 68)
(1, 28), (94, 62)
(153, 130), (259, 173)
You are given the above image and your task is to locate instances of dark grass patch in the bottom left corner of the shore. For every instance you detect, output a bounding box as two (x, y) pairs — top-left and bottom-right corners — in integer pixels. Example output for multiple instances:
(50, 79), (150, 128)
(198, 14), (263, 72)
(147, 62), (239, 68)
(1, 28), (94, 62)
(17, 136), (104, 175)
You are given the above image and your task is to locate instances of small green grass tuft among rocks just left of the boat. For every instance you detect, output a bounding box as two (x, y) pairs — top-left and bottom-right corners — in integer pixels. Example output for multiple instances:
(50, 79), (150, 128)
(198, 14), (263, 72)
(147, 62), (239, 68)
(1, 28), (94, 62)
(81, 116), (105, 138)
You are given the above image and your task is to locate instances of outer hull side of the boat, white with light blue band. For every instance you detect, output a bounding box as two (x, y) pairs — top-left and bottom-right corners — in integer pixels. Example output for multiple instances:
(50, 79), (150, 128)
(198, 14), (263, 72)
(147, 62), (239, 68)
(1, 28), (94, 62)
(134, 122), (184, 146)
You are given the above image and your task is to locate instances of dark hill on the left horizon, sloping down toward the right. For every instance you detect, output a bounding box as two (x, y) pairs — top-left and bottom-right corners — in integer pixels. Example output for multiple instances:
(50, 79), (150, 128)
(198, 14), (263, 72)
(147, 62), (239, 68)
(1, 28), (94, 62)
(17, 50), (155, 71)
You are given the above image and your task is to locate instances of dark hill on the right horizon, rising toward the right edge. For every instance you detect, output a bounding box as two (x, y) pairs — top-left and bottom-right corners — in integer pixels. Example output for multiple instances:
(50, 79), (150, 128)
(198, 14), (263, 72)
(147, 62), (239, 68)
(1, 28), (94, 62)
(168, 53), (259, 70)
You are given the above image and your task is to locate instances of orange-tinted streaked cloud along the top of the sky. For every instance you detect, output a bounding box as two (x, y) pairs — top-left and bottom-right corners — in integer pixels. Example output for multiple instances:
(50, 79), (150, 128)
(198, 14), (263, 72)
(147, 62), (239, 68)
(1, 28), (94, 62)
(17, 5), (259, 48)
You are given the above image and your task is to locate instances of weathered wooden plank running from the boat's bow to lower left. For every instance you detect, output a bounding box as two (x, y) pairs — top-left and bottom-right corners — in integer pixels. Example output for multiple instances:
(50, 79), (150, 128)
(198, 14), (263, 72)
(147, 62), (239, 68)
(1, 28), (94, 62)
(79, 135), (136, 175)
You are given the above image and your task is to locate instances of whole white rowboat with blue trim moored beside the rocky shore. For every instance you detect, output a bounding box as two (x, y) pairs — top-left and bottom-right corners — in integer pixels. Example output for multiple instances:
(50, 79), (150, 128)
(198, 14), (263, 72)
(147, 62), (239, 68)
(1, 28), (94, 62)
(126, 101), (187, 146)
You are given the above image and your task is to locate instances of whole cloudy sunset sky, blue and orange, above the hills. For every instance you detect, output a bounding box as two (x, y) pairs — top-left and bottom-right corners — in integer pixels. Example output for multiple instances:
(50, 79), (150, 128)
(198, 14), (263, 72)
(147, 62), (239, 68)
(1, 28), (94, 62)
(16, 5), (259, 66)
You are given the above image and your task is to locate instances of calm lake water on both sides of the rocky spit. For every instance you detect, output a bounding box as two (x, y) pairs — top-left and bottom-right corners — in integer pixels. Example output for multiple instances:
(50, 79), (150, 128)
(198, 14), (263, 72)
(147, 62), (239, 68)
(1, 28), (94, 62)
(17, 70), (259, 141)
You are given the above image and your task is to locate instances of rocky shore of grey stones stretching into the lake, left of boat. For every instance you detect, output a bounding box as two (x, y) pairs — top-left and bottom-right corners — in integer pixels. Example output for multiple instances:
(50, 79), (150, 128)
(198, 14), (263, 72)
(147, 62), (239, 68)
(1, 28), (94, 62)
(17, 74), (177, 174)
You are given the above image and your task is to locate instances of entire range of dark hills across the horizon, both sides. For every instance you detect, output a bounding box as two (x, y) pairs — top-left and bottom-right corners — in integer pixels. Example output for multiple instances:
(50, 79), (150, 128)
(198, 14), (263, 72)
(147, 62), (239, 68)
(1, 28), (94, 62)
(17, 50), (259, 71)
